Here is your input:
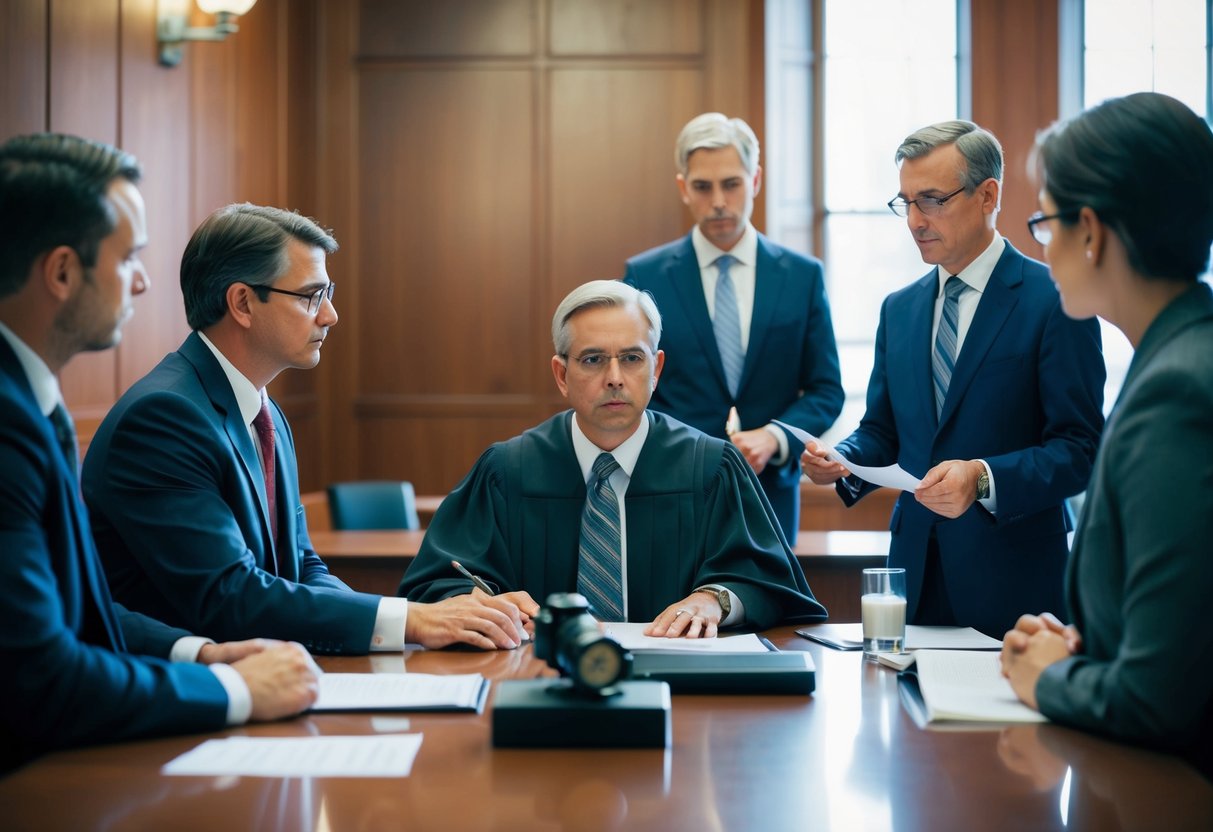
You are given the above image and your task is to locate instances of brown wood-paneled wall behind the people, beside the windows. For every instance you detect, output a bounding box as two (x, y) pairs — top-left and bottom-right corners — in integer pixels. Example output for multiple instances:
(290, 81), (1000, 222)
(0, 0), (1057, 502)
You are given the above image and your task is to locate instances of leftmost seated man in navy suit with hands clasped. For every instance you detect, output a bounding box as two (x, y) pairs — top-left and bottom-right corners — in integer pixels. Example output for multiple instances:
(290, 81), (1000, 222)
(0, 135), (317, 773)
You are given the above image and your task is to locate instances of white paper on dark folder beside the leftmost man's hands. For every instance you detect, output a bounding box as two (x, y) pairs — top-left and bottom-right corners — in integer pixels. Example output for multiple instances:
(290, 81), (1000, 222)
(312, 673), (484, 711)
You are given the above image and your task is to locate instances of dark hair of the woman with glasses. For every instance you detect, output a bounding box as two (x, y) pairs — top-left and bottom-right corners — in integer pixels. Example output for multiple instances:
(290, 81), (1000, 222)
(1035, 92), (1213, 280)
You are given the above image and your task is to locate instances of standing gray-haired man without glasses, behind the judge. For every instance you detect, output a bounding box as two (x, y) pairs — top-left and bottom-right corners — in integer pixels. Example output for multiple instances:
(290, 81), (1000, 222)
(623, 113), (844, 545)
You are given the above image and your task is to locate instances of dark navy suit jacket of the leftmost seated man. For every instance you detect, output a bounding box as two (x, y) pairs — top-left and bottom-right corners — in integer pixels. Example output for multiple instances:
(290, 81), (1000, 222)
(0, 338), (228, 771)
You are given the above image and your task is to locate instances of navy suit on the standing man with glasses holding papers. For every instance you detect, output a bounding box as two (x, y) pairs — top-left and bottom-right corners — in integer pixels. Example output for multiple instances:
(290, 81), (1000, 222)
(837, 243), (1105, 638)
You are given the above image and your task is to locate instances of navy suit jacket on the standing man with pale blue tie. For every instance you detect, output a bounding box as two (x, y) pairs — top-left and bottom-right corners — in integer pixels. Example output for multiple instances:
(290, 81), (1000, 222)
(623, 234), (844, 543)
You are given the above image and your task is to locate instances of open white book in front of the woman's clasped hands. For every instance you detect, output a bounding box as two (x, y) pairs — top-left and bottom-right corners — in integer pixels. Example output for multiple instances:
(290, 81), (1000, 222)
(915, 650), (1048, 723)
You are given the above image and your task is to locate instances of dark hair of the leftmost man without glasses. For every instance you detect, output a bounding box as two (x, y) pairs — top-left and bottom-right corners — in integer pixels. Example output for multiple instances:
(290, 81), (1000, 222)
(0, 133), (142, 303)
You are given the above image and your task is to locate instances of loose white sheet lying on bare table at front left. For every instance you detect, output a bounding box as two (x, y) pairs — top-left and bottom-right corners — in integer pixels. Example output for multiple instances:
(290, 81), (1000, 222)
(161, 734), (421, 777)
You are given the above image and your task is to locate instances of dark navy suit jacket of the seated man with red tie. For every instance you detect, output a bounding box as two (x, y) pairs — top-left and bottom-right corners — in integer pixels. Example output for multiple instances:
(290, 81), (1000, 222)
(84, 334), (378, 654)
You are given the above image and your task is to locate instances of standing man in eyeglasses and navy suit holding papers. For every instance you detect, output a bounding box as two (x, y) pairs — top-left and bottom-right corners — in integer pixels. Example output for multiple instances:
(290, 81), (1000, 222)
(802, 121), (1105, 637)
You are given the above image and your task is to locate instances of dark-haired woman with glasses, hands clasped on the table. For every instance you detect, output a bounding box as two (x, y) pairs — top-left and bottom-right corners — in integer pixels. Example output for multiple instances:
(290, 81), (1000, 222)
(1002, 92), (1213, 777)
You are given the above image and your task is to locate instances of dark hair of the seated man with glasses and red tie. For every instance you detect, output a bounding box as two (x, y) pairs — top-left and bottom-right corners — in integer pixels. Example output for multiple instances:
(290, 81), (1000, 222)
(181, 203), (337, 330)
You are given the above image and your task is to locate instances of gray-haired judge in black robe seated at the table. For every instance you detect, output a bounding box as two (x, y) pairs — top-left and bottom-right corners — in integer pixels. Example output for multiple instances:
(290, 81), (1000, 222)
(400, 280), (826, 638)
